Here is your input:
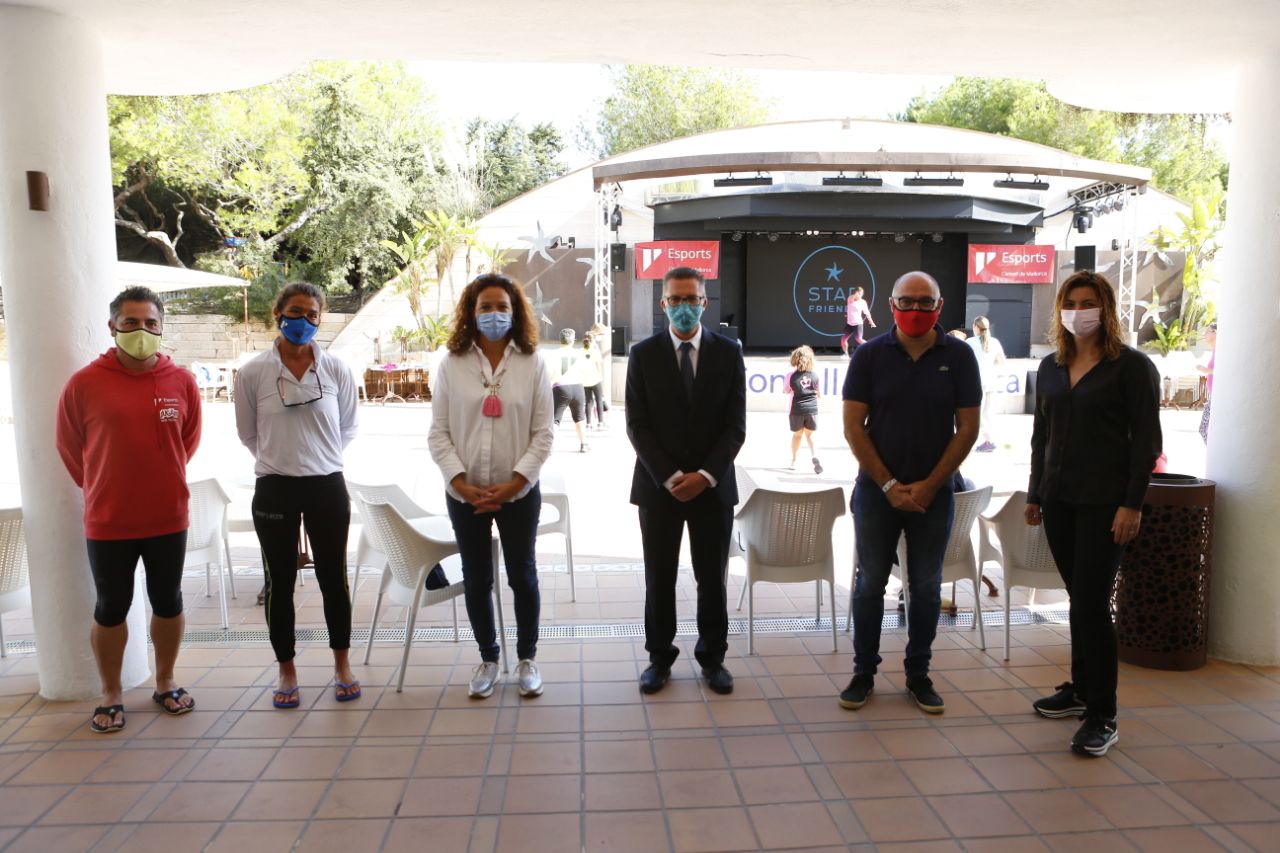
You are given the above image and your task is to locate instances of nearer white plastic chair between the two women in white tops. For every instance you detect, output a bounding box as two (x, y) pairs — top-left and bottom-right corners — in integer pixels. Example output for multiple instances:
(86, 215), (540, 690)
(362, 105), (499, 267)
(356, 496), (463, 693)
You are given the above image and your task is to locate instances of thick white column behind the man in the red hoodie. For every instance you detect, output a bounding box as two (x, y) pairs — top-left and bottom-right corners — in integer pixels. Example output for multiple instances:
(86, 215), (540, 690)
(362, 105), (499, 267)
(0, 5), (150, 699)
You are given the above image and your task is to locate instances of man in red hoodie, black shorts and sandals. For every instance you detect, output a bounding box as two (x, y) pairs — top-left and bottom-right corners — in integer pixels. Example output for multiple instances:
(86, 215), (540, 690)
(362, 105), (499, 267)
(58, 287), (201, 733)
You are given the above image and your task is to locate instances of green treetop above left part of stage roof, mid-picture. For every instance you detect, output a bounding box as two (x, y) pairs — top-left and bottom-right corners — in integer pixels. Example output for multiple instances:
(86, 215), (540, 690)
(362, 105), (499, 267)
(579, 65), (769, 158)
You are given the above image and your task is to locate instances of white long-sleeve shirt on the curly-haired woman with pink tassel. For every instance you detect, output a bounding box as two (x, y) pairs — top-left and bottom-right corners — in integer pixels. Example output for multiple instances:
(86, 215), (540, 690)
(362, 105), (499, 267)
(428, 342), (554, 501)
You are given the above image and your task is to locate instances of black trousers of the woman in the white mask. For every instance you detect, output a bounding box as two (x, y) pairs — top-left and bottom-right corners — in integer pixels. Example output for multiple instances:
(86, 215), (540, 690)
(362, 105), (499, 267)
(1041, 502), (1124, 720)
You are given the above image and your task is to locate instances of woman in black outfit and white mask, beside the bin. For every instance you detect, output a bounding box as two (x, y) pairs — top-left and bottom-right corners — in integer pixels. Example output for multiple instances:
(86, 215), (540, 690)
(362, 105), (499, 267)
(1025, 270), (1161, 756)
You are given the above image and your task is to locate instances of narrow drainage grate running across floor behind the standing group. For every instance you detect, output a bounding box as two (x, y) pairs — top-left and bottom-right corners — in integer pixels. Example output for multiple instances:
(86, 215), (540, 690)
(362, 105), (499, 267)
(5, 608), (1068, 654)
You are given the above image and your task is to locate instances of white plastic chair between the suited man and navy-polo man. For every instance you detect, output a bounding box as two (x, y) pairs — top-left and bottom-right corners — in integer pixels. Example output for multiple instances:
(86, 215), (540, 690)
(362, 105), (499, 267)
(737, 487), (845, 654)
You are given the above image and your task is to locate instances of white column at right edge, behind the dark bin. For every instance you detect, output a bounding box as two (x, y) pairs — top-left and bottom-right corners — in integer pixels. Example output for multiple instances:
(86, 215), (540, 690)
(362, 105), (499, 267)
(1208, 55), (1280, 666)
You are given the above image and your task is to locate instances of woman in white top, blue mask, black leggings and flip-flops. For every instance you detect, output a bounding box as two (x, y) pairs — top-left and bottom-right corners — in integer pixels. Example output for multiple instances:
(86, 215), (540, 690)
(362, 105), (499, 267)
(236, 282), (360, 708)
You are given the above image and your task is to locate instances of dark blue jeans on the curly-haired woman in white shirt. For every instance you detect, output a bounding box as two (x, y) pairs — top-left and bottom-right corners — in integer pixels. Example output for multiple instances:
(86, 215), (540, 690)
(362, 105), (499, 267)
(445, 483), (543, 662)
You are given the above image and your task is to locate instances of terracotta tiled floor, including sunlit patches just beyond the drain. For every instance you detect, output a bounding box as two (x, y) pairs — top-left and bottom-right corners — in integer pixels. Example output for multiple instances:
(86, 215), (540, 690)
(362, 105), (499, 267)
(0, 560), (1280, 853)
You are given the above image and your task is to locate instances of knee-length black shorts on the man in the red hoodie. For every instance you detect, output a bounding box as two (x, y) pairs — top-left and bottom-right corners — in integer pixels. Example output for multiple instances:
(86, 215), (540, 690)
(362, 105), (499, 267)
(86, 530), (187, 628)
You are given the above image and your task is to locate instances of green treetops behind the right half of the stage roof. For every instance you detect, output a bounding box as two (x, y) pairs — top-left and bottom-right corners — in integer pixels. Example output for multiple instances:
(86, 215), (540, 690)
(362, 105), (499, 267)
(895, 77), (1228, 199)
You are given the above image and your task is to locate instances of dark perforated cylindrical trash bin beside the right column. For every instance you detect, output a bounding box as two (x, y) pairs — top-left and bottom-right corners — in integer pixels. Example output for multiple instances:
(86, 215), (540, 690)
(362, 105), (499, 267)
(1114, 474), (1216, 670)
